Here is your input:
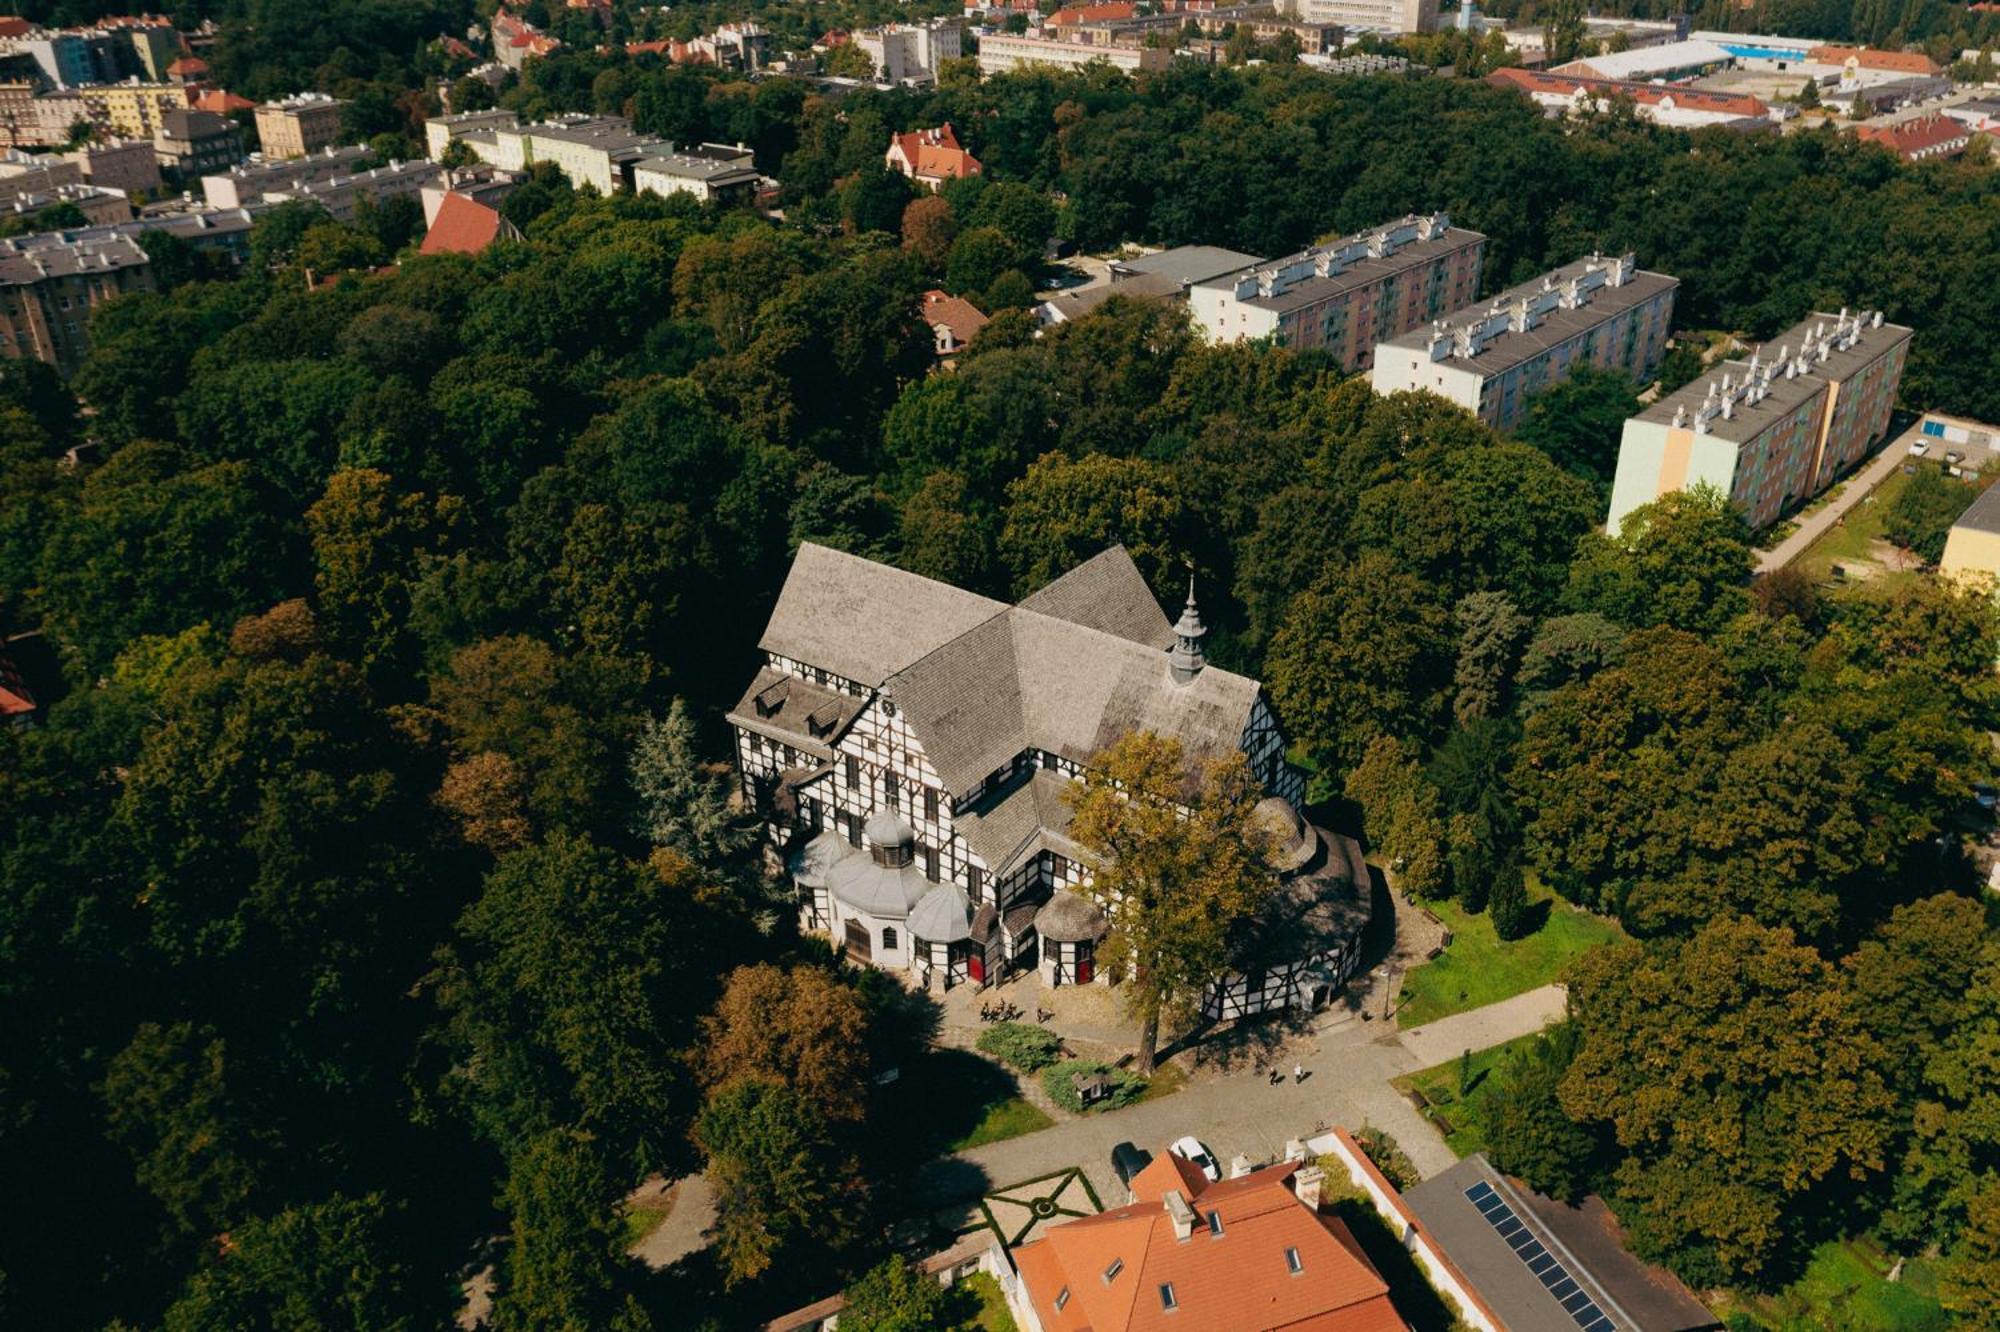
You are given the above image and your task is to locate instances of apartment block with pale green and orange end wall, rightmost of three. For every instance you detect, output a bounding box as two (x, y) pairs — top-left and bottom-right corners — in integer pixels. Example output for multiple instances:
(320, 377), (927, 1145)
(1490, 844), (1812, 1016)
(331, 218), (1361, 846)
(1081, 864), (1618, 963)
(1608, 310), (1910, 532)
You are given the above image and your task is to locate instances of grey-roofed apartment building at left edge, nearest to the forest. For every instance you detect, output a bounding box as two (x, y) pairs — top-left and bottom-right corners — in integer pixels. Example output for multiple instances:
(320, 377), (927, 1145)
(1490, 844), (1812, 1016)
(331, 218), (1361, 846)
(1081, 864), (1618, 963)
(0, 234), (152, 374)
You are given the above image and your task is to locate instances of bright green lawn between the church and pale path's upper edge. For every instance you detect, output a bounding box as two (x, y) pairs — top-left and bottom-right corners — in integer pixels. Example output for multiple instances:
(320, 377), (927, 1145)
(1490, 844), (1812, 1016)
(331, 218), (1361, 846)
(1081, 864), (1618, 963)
(1396, 874), (1624, 1026)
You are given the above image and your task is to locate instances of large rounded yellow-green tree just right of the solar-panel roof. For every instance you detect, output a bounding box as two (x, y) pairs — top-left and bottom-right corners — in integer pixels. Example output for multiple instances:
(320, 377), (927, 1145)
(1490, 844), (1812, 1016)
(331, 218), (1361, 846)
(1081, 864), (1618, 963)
(1562, 918), (1896, 1284)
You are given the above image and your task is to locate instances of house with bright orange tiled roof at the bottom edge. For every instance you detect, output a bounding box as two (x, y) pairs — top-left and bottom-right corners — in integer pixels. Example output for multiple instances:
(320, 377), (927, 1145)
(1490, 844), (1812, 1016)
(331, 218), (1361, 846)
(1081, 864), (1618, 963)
(1014, 1152), (1408, 1332)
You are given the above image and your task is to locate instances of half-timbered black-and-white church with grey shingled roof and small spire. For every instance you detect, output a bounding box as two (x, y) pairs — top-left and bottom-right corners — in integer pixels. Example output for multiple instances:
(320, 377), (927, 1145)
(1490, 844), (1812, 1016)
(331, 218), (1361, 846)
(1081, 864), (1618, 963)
(730, 544), (1368, 1016)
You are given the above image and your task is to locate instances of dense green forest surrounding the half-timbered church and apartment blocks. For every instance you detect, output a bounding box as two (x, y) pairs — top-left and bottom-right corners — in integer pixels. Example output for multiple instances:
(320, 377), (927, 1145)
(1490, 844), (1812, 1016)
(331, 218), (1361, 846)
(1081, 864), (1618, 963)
(0, 60), (2000, 1328)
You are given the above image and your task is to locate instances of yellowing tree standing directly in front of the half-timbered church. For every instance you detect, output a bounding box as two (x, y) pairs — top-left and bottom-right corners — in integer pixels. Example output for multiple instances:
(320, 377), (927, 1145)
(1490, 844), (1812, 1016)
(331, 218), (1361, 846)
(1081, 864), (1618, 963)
(1070, 732), (1278, 1074)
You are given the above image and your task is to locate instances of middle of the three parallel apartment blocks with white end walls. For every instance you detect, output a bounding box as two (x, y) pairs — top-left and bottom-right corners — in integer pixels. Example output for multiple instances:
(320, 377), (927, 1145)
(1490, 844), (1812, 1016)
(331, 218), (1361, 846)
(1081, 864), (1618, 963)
(1370, 254), (1680, 430)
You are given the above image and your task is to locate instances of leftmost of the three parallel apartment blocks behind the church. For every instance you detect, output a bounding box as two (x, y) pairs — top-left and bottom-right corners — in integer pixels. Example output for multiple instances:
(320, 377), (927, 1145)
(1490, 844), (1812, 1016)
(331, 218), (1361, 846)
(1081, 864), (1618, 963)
(1188, 212), (1486, 370)
